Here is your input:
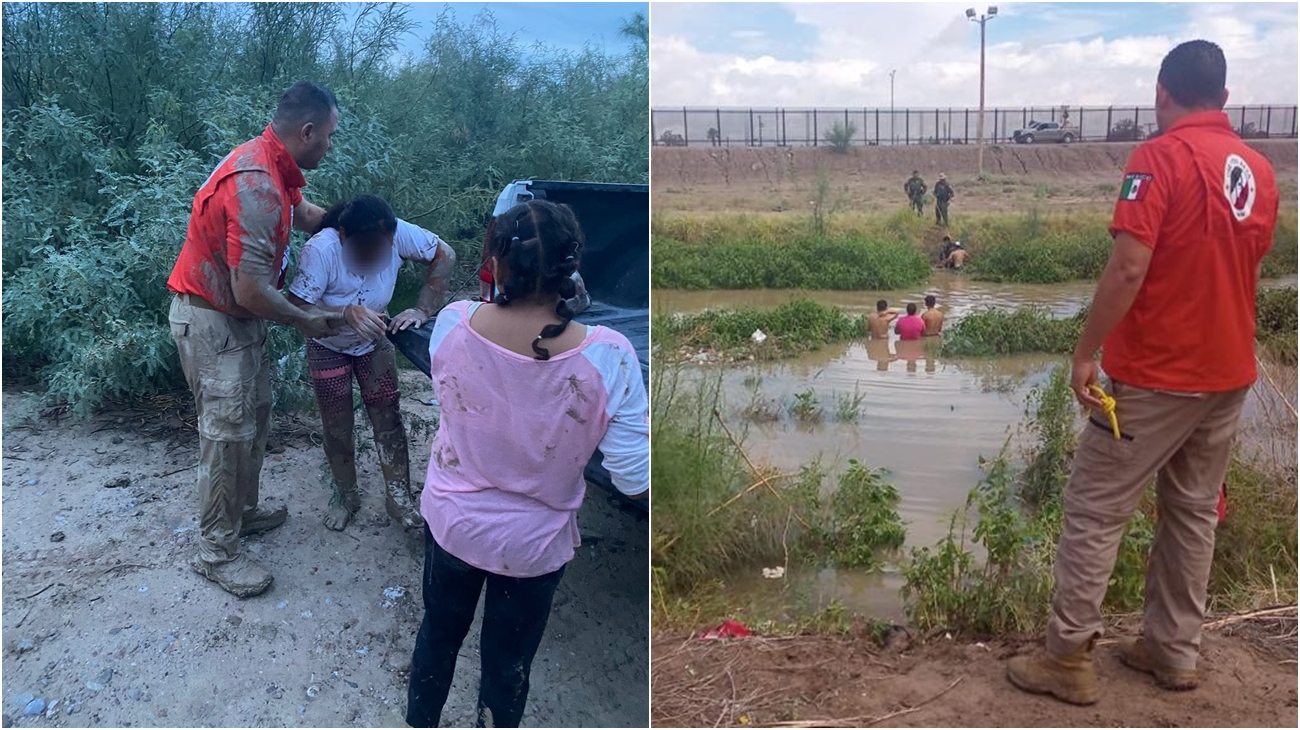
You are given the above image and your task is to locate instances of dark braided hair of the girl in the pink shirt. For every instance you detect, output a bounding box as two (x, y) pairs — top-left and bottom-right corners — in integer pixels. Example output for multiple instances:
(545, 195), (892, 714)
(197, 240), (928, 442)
(488, 200), (584, 360)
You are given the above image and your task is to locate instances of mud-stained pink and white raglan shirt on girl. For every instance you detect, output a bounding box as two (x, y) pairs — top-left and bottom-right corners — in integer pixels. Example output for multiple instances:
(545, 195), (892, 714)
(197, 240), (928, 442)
(420, 301), (650, 578)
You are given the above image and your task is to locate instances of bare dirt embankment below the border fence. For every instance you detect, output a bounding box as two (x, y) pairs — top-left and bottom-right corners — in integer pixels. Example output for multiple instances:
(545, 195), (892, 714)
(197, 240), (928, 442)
(651, 140), (1296, 212)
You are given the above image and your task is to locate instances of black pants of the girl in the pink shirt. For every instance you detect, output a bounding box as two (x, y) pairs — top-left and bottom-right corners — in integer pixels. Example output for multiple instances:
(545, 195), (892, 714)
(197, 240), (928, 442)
(407, 530), (564, 727)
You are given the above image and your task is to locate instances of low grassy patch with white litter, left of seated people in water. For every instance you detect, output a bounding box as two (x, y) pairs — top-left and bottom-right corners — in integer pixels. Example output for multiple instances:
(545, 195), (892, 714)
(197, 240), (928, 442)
(651, 299), (866, 361)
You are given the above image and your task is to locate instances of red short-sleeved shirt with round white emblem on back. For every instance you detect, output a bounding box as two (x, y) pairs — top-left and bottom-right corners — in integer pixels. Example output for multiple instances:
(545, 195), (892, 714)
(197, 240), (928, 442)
(1101, 112), (1278, 392)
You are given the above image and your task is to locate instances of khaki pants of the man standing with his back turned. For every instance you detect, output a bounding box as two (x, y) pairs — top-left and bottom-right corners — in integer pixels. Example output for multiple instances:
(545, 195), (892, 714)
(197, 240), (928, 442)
(1047, 383), (1249, 670)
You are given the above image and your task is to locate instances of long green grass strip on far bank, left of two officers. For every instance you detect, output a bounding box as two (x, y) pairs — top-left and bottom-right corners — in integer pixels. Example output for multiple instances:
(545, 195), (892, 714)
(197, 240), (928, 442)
(653, 235), (930, 290)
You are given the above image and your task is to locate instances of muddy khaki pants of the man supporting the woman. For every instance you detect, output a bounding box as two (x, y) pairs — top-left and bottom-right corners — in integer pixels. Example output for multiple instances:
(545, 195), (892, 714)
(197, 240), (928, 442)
(169, 294), (270, 564)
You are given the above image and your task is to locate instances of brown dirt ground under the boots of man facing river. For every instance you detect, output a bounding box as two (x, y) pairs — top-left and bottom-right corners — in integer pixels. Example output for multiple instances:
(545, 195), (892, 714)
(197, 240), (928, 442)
(651, 613), (1296, 727)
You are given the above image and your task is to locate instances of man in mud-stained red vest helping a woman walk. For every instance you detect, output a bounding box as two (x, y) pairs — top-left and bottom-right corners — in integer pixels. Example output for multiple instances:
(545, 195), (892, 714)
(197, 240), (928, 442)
(168, 82), (351, 598)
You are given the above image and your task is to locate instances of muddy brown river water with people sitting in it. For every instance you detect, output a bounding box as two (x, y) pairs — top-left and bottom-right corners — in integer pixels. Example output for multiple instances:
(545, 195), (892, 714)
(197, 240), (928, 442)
(651, 274), (1296, 618)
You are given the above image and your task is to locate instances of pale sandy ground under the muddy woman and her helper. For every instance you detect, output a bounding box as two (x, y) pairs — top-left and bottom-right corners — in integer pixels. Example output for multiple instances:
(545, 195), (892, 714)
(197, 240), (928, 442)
(3, 371), (649, 727)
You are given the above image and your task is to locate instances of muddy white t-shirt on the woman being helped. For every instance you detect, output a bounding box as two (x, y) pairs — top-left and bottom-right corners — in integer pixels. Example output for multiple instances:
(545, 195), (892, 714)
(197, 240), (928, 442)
(289, 218), (447, 356)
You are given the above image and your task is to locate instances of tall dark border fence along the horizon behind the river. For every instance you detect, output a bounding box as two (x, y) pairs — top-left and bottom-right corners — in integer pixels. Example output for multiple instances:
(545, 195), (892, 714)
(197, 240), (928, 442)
(650, 105), (1296, 147)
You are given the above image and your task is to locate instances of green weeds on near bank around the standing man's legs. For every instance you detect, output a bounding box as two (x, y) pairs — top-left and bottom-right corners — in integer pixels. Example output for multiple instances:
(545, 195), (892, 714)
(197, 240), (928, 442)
(904, 368), (1297, 636)
